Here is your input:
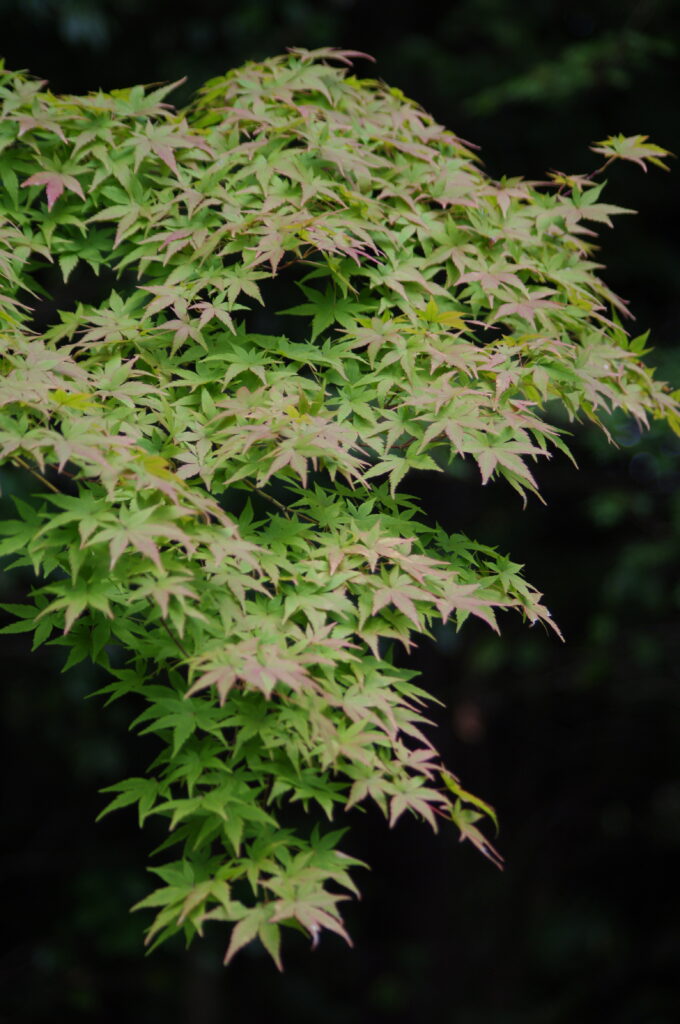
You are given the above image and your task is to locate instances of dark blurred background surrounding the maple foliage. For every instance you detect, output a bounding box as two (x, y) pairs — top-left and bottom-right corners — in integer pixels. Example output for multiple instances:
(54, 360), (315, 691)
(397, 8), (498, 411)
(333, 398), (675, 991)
(0, 0), (680, 1024)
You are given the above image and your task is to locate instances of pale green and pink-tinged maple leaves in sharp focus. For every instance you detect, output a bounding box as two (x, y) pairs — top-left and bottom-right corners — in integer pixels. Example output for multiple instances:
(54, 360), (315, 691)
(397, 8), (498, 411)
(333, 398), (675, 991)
(0, 49), (680, 965)
